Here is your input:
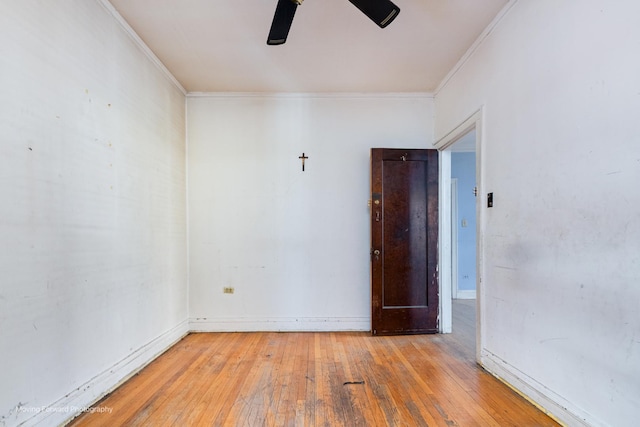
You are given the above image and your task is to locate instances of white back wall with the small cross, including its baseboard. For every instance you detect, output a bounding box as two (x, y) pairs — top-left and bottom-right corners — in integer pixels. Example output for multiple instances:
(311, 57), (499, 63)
(188, 94), (433, 331)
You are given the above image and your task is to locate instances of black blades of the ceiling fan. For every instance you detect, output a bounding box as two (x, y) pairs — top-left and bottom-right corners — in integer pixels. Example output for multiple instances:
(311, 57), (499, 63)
(267, 0), (400, 45)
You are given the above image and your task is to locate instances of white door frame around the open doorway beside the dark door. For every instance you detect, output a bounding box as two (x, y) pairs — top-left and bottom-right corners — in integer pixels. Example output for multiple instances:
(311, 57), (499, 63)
(433, 107), (485, 363)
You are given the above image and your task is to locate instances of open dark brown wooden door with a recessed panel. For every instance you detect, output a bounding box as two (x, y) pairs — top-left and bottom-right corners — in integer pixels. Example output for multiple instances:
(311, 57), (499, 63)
(371, 148), (439, 335)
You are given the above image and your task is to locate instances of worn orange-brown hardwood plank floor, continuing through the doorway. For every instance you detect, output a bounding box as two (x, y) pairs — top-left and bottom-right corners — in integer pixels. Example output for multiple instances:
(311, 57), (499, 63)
(71, 301), (557, 427)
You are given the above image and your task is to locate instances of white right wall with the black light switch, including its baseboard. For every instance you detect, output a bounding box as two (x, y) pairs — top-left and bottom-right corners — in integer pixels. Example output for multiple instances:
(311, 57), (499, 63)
(436, 0), (640, 426)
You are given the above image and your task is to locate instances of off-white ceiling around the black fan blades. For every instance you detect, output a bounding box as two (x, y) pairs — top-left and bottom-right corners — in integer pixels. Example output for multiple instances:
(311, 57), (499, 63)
(109, 0), (508, 93)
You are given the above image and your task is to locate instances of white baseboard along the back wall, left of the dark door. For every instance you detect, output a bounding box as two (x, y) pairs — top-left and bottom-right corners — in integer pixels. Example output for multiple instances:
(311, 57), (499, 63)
(189, 317), (371, 332)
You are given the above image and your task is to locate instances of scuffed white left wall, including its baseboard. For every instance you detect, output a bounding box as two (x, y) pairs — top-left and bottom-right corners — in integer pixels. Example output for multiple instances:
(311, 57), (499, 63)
(0, 0), (188, 426)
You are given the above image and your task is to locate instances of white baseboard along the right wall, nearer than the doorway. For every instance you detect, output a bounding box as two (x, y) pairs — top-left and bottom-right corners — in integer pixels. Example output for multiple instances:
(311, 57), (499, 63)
(481, 349), (606, 427)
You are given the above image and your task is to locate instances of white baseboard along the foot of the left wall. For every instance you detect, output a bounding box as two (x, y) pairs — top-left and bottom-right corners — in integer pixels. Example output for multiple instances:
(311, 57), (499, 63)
(20, 320), (189, 426)
